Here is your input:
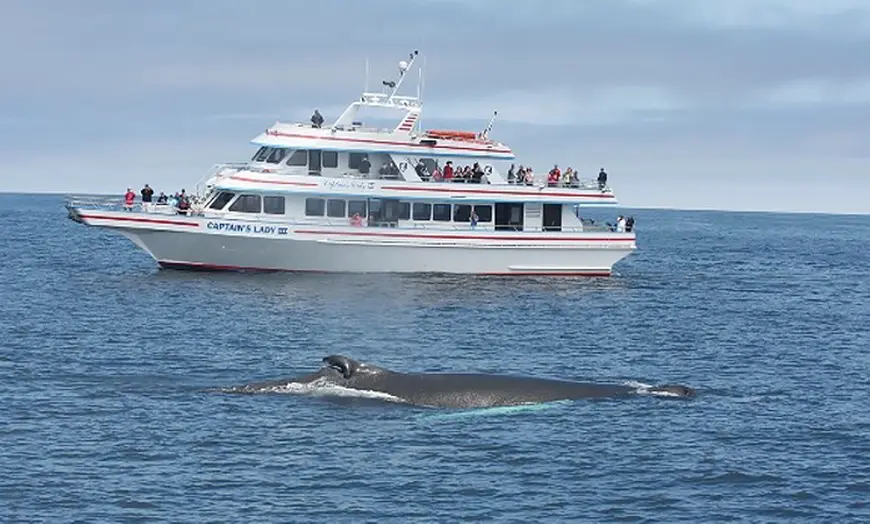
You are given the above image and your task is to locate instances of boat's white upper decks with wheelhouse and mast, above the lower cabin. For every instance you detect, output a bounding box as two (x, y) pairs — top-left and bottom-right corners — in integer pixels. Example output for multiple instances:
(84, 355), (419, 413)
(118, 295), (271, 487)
(184, 51), (617, 205)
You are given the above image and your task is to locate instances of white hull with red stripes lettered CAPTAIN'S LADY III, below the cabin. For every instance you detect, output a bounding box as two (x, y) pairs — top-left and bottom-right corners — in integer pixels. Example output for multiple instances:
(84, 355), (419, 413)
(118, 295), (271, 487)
(82, 213), (635, 276)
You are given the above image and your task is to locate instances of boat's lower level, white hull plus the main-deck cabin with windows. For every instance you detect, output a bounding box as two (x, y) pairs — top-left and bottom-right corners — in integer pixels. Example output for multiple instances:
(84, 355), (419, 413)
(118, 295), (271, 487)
(67, 194), (636, 276)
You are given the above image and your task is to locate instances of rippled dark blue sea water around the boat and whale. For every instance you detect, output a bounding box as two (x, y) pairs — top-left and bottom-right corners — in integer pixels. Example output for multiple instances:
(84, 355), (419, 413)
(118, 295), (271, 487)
(0, 195), (870, 523)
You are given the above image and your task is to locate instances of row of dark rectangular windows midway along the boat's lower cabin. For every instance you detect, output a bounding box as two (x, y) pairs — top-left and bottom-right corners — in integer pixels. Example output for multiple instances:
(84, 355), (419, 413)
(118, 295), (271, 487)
(305, 198), (492, 222)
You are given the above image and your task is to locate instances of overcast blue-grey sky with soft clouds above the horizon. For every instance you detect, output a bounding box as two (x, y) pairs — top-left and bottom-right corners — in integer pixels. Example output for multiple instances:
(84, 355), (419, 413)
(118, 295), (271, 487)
(0, 0), (870, 213)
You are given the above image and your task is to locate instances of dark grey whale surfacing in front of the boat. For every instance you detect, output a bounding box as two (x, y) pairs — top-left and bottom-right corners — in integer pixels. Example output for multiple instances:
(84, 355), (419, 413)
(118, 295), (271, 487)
(224, 355), (696, 408)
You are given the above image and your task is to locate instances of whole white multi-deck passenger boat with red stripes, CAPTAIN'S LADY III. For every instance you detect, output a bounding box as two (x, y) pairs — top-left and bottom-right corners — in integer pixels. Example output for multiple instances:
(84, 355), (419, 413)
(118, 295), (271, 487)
(66, 51), (636, 276)
